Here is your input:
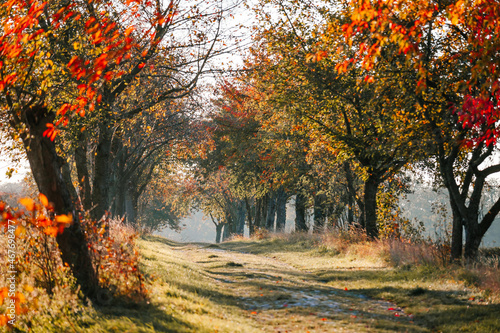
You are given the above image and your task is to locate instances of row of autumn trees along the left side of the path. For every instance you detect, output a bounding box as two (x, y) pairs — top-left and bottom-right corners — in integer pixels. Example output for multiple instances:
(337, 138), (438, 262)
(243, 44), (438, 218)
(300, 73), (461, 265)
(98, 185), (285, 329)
(0, 0), (240, 296)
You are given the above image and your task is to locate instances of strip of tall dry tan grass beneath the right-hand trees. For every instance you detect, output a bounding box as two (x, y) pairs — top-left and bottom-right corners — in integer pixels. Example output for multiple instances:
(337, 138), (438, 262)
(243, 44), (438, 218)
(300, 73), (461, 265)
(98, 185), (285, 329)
(245, 228), (500, 300)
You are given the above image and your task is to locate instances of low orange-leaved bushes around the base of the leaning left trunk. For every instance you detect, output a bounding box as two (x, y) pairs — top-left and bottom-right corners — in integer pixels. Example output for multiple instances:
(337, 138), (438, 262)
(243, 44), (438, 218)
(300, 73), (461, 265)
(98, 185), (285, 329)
(0, 194), (147, 326)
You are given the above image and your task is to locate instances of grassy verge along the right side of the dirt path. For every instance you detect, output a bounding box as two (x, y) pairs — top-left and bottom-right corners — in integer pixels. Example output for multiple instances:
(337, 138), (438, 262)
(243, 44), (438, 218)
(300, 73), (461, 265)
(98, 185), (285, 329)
(221, 235), (500, 332)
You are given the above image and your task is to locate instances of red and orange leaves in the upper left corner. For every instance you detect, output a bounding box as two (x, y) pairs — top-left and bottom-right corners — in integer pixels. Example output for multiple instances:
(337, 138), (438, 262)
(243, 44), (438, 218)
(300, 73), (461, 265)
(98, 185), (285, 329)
(0, 0), (175, 135)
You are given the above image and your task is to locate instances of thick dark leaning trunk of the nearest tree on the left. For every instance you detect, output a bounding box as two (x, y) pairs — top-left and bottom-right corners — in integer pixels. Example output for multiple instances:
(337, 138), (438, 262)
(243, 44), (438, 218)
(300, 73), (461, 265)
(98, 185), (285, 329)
(23, 107), (99, 298)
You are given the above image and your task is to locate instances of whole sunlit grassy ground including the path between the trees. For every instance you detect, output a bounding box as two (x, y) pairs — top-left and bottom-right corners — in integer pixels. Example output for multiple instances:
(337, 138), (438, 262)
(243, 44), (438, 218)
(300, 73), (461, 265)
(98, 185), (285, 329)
(0, 230), (500, 333)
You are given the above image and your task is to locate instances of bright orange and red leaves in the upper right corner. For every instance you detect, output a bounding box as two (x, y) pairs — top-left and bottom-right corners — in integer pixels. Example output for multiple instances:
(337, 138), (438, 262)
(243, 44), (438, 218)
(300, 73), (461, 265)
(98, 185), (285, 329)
(334, 0), (500, 146)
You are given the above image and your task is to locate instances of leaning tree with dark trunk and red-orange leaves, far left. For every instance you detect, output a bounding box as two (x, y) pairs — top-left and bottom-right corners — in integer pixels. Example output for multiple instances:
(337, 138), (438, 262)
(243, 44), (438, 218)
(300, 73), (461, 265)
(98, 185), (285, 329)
(0, 0), (153, 296)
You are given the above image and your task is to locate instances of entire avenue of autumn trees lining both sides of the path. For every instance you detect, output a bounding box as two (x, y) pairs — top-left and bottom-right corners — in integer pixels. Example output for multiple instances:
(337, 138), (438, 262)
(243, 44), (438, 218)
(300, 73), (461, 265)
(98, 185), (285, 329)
(0, 0), (500, 296)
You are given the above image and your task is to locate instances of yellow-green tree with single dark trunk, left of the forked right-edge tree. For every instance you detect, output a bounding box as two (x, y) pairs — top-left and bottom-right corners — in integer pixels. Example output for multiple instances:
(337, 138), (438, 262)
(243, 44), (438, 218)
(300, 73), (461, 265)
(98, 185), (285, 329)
(248, 1), (424, 237)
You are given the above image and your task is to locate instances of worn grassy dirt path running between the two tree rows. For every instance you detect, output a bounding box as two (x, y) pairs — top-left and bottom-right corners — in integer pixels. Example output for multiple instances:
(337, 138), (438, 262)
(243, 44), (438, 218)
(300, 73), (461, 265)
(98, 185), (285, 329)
(175, 244), (427, 332)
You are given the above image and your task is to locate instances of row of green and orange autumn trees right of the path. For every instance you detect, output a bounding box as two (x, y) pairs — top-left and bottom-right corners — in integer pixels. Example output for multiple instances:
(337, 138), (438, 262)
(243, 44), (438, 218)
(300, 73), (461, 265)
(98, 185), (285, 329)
(187, 0), (500, 260)
